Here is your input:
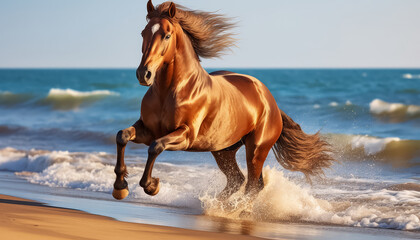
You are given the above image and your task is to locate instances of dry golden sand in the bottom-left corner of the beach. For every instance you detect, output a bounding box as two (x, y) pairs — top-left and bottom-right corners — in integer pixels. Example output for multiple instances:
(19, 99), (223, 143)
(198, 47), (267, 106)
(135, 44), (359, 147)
(0, 195), (261, 240)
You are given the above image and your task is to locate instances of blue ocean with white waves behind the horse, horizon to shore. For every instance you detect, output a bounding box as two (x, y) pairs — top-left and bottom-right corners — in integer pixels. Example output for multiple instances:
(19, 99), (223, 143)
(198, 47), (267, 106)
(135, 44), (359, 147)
(0, 69), (420, 238)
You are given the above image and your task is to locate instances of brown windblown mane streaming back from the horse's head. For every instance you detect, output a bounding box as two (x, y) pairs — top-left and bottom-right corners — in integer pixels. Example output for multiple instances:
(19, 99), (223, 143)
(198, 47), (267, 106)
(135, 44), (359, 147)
(146, 2), (235, 58)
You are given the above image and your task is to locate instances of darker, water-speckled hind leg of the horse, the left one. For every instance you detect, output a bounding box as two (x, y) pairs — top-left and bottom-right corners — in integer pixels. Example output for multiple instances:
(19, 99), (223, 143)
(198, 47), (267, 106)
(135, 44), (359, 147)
(211, 143), (245, 200)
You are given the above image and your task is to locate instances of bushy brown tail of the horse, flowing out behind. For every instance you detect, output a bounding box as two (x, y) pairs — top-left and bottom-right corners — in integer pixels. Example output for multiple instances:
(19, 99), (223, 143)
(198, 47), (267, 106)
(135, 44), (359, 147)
(273, 111), (334, 182)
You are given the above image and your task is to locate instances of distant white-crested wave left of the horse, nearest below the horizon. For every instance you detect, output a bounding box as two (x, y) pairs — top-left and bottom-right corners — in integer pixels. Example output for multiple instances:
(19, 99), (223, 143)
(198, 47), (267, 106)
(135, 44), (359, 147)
(41, 88), (119, 110)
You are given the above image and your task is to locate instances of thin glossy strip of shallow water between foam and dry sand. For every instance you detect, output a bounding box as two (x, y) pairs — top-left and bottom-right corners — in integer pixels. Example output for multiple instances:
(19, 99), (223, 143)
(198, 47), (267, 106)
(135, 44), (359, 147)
(0, 171), (419, 240)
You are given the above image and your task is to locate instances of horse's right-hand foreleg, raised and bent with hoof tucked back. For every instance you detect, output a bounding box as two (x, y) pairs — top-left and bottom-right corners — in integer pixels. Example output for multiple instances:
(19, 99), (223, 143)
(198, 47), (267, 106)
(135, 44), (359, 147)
(140, 125), (189, 196)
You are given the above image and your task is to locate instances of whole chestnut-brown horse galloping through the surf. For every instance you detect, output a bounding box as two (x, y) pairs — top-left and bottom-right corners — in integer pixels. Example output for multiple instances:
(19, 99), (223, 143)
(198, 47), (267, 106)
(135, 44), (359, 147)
(113, 0), (333, 199)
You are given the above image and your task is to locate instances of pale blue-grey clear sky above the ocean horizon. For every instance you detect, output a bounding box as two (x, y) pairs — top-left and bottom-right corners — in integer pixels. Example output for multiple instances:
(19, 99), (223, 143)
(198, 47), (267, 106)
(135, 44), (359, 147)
(0, 0), (420, 68)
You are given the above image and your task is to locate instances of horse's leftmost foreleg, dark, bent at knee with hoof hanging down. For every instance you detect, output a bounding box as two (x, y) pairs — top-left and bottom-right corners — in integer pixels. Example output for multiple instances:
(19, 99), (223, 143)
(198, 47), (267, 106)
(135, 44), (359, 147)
(112, 120), (150, 200)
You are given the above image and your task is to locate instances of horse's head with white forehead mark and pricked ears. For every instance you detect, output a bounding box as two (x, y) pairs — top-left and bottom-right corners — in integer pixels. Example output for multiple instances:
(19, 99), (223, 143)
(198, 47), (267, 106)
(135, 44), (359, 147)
(136, 0), (176, 86)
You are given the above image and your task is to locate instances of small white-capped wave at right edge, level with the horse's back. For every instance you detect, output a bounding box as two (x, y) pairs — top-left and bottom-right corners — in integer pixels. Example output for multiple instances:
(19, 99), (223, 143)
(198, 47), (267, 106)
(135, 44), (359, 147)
(369, 99), (420, 121)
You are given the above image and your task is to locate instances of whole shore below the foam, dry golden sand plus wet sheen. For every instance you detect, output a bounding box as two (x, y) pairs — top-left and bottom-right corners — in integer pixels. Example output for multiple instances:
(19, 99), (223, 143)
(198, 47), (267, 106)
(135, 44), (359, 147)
(0, 178), (419, 240)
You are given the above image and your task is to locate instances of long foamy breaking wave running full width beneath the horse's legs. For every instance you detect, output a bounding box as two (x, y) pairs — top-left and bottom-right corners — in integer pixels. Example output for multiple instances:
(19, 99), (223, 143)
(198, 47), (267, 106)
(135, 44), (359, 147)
(0, 148), (420, 230)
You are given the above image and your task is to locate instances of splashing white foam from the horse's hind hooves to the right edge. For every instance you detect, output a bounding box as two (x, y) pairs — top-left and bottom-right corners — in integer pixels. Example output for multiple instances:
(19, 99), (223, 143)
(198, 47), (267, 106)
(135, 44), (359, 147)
(200, 167), (420, 230)
